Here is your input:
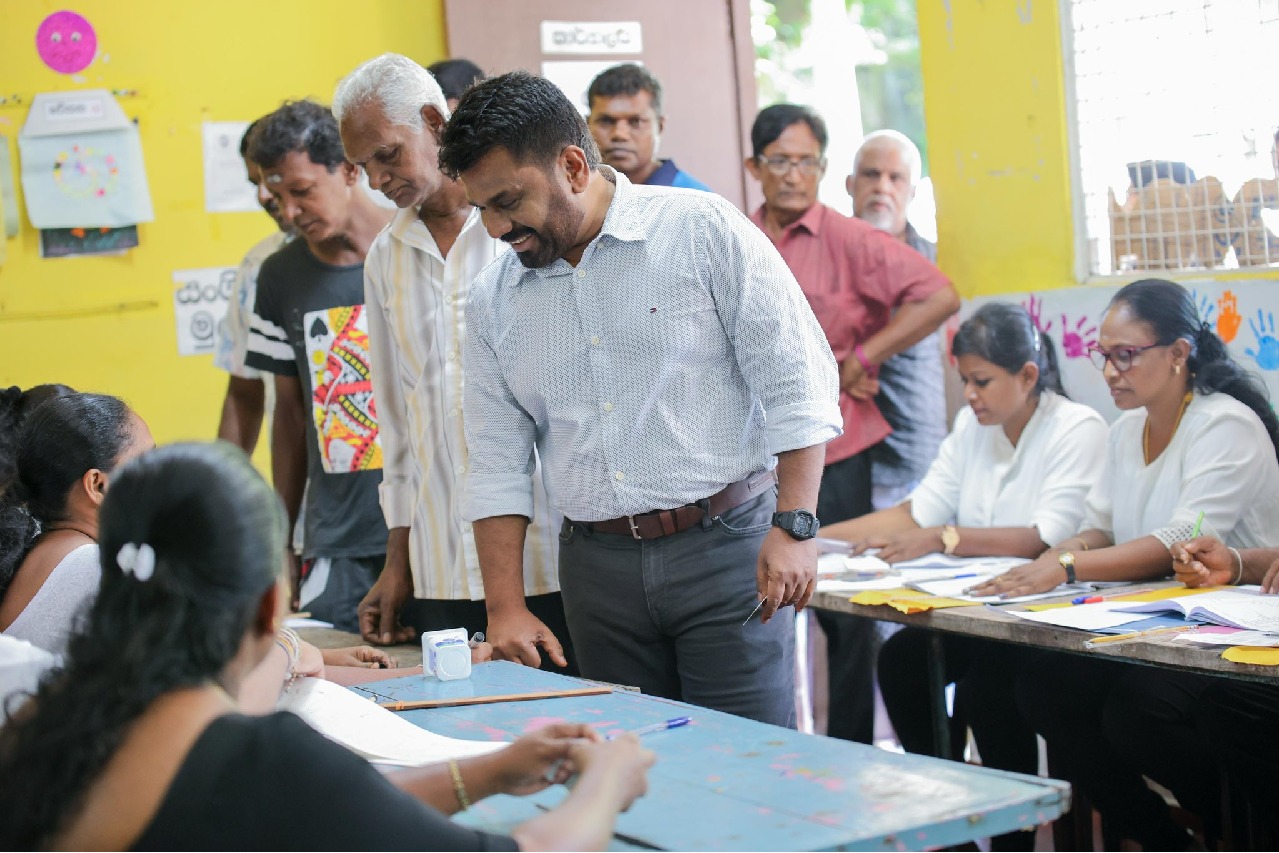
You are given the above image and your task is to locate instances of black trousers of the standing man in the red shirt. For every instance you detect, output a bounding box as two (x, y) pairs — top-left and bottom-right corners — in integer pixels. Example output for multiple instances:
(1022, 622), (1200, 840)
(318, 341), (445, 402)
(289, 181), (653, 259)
(813, 449), (880, 743)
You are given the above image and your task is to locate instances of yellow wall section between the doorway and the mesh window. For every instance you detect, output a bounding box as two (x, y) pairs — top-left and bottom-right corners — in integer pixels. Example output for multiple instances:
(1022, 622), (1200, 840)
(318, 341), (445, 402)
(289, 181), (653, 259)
(918, 0), (1076, 297)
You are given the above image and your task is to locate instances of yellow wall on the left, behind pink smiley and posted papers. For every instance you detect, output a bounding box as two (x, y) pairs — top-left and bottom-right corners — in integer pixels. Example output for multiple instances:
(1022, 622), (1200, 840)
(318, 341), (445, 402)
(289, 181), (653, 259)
(0, 0), (445, 441)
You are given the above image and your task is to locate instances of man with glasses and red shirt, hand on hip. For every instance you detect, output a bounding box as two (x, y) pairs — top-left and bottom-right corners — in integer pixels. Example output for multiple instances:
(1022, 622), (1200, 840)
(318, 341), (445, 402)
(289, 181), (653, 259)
(746, 104), (959, 743)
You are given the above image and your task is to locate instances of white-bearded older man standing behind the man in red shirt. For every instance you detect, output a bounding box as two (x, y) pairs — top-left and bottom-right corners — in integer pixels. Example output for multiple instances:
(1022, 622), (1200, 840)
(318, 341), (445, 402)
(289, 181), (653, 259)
(844, 130), (946, 509)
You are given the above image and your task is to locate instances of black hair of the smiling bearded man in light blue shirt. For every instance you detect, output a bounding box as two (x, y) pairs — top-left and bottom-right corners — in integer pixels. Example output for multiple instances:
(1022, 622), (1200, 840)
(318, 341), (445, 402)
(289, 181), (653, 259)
(440, 72), (600, 178)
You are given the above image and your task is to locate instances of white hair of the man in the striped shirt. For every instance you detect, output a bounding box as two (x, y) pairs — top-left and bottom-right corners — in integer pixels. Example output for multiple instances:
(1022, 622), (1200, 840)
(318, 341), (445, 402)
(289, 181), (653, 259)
(333, 54), (449, 130)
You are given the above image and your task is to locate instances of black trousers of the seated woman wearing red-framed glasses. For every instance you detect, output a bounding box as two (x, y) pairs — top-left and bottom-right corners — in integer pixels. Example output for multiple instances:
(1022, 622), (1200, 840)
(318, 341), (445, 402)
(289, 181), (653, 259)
(1017, 653), (1219, 850)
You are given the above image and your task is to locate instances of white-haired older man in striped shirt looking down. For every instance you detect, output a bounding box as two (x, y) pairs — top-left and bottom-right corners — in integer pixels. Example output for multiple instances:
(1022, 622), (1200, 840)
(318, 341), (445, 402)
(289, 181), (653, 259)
(333, 54), (576, 673)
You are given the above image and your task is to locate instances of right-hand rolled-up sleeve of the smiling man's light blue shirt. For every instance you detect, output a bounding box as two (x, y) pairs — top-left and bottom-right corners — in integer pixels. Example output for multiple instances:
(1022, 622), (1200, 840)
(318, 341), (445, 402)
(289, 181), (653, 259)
(696, 200), (843, 454)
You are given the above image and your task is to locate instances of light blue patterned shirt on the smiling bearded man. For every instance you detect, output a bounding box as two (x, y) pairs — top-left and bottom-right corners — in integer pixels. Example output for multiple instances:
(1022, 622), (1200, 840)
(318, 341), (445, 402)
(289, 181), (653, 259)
(463, 166), (842, 522)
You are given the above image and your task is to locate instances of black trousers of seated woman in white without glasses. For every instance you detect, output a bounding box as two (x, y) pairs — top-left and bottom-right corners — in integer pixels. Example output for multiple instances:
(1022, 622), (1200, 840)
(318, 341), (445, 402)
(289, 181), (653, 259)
(879, 628), (1039, 850)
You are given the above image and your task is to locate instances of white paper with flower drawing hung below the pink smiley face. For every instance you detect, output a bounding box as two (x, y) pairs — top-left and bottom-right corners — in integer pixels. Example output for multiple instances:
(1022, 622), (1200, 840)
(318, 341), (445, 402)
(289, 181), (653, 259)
(18, 90), (155, 229)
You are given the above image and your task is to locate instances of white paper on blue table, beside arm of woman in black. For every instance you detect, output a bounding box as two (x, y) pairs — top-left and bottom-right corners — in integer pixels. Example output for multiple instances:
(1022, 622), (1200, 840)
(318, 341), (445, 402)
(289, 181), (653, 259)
(279, 678), (506, 767)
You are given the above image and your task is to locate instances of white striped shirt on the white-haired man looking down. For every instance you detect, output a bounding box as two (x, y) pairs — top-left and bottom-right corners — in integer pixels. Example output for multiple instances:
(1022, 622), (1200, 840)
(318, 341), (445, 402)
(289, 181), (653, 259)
(365, 208), (559, 600)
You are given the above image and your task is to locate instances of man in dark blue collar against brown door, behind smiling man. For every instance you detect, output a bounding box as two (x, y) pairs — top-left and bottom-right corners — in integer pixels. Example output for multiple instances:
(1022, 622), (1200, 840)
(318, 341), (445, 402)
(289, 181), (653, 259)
(586, 63), (711, 192)
